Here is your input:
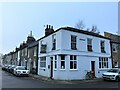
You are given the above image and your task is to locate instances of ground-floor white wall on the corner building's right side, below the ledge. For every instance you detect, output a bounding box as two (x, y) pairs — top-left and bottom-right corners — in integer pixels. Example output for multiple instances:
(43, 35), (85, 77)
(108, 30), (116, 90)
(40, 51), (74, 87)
(53, 55), (111, 80)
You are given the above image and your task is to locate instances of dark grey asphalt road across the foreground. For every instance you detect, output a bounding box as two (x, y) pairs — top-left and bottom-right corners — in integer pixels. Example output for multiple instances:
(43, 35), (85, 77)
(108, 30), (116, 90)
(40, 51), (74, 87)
(2, 71), (120, 88)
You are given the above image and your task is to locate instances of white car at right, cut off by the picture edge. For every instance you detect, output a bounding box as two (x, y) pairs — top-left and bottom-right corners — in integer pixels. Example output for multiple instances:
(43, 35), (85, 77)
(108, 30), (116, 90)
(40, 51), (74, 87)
(102, 68), (120, 81)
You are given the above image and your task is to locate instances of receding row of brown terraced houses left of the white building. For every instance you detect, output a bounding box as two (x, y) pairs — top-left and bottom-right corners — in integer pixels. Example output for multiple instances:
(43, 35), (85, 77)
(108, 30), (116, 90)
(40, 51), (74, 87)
(3, 32), (38, 74)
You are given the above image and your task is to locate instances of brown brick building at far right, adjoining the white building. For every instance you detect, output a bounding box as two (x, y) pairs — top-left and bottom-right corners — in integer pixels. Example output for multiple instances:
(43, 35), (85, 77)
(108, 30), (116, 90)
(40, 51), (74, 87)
(104, 32), (120, 67)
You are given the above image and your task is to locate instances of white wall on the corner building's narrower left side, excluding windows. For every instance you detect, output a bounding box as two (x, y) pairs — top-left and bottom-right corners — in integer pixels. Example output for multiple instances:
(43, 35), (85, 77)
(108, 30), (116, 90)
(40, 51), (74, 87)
(38, 31), (61, 77)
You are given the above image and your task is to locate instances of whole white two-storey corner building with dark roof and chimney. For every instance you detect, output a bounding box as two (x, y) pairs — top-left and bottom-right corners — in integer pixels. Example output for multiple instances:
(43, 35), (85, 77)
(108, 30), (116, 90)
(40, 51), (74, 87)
(38, 25), (112, 80)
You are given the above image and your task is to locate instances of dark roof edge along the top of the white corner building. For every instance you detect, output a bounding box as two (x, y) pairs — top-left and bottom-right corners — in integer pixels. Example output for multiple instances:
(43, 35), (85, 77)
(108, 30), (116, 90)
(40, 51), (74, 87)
(37, 27), (110, 41)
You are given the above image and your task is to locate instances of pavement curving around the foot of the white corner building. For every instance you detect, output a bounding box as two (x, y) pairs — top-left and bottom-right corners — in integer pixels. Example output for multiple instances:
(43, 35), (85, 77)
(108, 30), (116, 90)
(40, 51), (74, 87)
(29, 74), (103, 84)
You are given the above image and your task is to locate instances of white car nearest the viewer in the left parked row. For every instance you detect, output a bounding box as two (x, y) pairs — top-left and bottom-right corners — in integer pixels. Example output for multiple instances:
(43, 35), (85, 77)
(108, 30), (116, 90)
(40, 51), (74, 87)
(13, 66), (30, 76)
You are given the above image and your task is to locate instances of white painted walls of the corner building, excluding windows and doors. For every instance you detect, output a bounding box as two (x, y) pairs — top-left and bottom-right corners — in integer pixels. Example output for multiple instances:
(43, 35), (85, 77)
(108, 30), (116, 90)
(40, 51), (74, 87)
(38, 30), (112, 80)
